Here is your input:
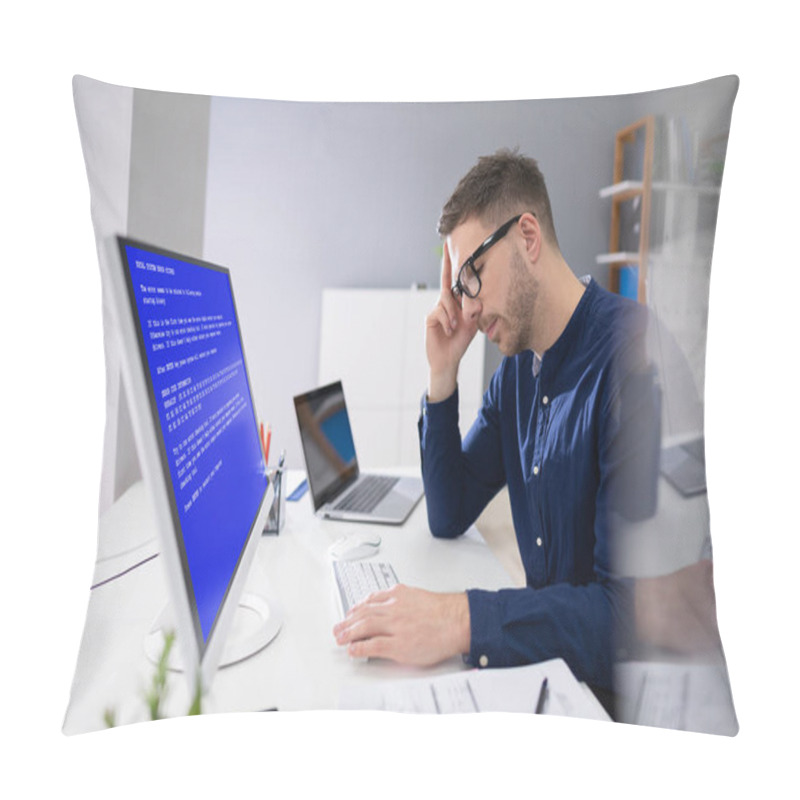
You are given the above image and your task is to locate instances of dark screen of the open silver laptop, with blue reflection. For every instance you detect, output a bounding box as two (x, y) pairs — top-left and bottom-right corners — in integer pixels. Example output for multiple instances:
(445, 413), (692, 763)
(294, 381), (358, 511)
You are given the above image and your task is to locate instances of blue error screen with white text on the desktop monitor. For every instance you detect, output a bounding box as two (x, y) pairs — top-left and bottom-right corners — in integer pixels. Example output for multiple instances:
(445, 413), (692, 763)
(124, 244), (267, 642)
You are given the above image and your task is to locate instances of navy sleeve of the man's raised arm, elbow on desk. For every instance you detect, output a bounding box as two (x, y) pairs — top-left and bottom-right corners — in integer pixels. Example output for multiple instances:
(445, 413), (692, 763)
(418, 380), (505, 538)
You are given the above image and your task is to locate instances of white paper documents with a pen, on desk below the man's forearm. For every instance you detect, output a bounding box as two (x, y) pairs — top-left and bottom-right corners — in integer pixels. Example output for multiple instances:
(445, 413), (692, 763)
(339, 658), (610, 720)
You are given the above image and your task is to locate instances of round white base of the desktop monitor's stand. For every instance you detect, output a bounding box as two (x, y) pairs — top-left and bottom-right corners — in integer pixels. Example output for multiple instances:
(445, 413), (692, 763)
(144, 592), (283, 672)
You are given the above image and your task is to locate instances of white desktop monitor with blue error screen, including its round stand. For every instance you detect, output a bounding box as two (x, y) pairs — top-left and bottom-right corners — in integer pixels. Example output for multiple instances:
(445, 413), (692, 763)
(110, 237), (280, 690)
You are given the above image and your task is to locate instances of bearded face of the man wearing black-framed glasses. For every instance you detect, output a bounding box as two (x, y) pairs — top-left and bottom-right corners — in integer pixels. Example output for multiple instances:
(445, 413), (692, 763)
(448, 219), (539, 356)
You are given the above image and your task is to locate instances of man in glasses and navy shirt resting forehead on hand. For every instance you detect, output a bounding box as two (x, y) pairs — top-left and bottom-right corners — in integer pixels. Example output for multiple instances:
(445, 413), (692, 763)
(334, 151), (658, 688)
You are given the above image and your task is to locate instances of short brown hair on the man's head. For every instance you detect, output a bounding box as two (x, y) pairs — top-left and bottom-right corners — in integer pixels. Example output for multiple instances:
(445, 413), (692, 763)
(438, 149), (558, 247)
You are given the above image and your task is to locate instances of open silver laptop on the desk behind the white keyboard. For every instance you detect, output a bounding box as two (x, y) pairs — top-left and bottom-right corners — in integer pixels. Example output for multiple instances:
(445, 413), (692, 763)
(294, 381), (424, 525)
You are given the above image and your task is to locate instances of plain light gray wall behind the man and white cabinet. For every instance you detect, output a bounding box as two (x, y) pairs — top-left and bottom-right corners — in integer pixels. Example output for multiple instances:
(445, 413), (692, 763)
(203, 98), (630, 466)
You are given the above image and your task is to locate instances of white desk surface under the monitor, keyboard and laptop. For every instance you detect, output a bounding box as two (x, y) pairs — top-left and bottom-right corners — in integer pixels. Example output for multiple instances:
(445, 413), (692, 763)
(64, 472), (513, 733)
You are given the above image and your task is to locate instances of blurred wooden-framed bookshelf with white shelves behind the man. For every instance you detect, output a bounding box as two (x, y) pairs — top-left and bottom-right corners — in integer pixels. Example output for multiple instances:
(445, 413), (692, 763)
(596, 114), (728, 430)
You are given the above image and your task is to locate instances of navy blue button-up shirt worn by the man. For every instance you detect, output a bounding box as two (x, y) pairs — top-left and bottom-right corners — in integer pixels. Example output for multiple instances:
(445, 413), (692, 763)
(419, 281), (659, 688)
